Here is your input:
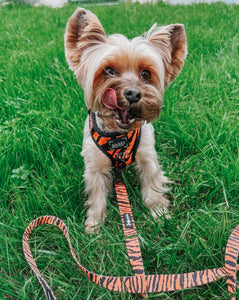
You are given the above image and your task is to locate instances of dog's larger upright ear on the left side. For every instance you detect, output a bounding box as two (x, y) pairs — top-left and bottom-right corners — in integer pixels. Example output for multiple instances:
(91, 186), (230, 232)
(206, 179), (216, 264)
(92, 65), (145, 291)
(65, 7), (106, 71)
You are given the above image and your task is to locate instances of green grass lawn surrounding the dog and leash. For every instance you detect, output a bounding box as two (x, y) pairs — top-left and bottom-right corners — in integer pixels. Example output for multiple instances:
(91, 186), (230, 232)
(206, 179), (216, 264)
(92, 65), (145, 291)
(0, 3), (239, 300)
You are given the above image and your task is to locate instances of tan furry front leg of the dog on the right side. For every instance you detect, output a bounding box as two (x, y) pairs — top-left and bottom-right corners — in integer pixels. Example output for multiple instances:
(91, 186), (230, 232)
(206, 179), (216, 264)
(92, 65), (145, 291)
(135, 124), (170, 218)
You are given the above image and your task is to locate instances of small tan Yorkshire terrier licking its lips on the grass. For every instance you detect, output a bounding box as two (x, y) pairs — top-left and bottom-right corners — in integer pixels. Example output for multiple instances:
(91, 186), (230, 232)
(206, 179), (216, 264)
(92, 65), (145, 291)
(64, 8), (187, 233)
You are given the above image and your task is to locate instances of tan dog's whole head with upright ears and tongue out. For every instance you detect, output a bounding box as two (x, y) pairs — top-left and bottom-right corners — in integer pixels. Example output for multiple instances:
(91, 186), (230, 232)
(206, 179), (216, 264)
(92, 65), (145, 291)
(65, 8), (187, 131)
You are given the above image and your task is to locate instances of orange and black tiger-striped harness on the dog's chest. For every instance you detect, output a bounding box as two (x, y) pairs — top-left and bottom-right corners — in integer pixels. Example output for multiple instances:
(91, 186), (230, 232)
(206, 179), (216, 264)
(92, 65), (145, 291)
(89, 110), (141, 171)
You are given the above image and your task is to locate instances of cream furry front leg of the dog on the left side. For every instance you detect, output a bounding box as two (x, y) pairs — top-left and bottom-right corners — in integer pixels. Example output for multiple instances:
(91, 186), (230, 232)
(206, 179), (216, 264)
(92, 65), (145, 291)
(81, 121), (112, 233)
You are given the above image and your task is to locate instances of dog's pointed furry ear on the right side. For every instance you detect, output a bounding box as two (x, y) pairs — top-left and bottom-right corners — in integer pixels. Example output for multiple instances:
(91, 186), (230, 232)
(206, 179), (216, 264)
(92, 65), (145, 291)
(147, 24), (187, 86)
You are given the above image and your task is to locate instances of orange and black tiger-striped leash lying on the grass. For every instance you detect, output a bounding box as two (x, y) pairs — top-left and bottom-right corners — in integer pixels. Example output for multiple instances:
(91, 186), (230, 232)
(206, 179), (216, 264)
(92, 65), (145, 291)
(23, 197), (239, 300)
